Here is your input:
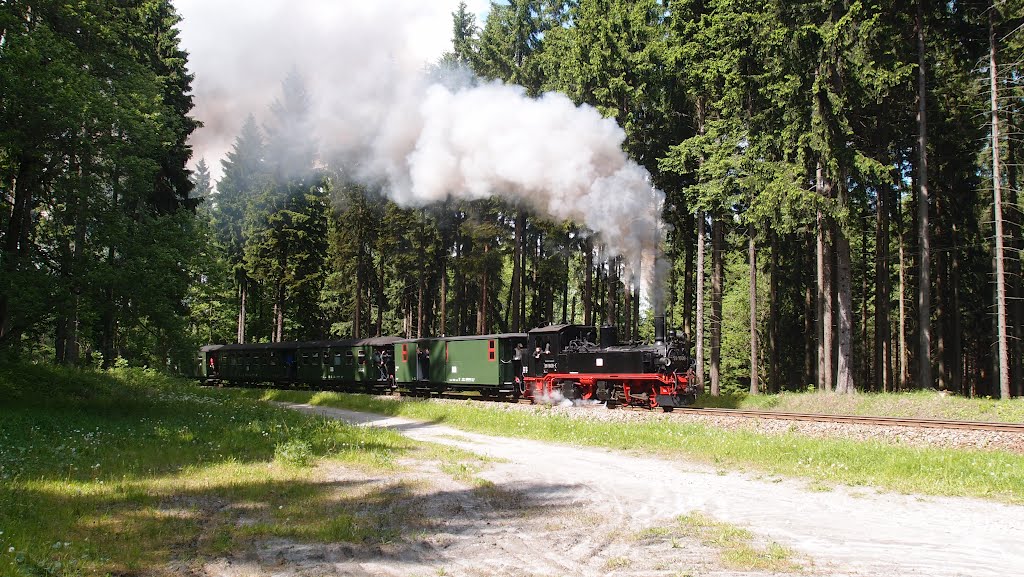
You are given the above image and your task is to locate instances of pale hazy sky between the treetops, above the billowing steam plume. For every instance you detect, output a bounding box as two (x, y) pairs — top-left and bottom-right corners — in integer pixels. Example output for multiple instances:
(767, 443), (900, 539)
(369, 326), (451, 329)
(174, 0), (489, 179)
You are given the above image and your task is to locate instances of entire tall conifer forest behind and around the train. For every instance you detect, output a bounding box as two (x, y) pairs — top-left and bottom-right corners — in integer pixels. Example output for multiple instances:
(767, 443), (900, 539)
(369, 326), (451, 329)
(0, 0), (1024, 398)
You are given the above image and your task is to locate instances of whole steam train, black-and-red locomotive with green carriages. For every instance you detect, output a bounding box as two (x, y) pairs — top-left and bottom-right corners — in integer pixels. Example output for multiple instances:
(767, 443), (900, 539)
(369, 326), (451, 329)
(198, 317), (699, 411)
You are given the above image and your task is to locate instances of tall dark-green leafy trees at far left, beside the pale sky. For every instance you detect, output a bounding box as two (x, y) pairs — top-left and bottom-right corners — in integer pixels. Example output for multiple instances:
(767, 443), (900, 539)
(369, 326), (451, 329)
(0, 0), (198, 366)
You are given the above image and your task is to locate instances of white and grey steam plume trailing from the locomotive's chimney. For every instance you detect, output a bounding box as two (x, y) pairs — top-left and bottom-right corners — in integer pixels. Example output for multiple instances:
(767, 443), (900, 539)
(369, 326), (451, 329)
(176, 0), (665, 310)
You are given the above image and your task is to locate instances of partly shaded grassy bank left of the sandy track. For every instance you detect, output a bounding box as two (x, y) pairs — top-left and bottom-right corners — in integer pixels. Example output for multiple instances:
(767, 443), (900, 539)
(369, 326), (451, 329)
(0, 365), (413, 577)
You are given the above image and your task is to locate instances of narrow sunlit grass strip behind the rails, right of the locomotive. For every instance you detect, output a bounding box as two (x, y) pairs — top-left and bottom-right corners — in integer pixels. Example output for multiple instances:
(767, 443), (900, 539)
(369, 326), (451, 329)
(697, 390), (1024, 422)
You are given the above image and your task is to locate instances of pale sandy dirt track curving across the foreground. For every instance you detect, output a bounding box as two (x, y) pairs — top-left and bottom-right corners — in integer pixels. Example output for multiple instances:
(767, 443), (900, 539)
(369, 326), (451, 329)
(195, 406), (1024, 577)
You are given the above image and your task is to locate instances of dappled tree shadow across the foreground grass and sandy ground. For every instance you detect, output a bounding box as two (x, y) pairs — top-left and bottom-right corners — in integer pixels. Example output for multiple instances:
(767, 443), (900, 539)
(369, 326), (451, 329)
(11, 473), (579, 575)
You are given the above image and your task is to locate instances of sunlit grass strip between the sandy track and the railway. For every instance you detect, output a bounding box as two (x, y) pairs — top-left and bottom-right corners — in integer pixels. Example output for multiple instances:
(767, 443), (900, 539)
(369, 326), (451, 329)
(248, 390), (1024, 503)
